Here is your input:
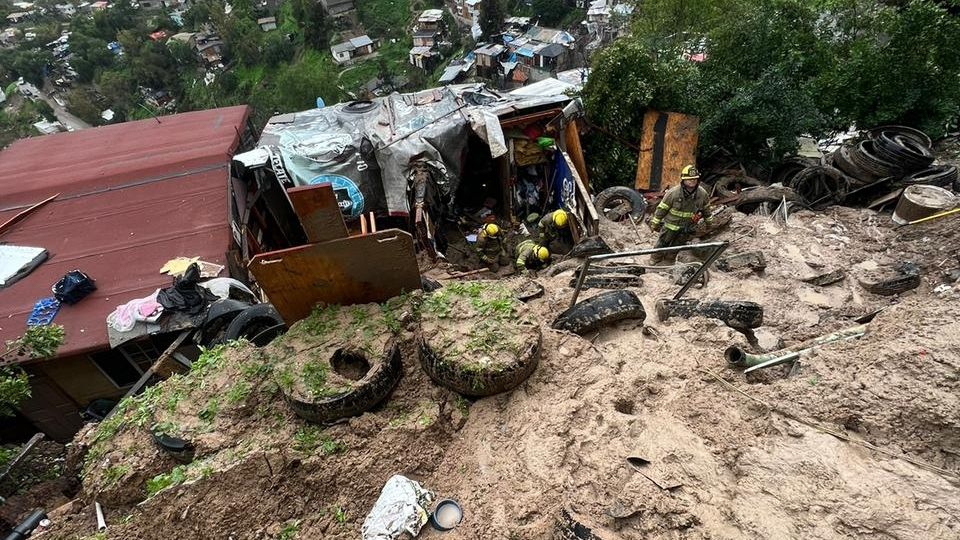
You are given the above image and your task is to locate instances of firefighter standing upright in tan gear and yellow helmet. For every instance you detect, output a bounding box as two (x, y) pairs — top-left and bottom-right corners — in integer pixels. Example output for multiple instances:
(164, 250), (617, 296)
(650, 165), (713, 264)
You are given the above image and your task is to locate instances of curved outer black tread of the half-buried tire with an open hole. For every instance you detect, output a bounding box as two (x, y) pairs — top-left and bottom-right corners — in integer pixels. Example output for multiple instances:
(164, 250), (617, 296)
(283, 341), (403, 424)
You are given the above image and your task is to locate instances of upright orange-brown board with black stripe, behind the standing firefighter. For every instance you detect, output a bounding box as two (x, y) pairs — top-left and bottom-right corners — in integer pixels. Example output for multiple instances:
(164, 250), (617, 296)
(636, 110), (700, 191)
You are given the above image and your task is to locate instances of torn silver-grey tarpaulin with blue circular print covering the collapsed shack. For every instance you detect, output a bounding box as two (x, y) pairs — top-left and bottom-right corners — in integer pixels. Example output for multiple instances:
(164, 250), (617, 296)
(259, 85), (571, 219)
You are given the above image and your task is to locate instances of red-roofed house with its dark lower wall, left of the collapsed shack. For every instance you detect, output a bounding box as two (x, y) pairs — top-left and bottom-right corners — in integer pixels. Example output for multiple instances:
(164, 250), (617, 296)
(0, 106), (253, 440)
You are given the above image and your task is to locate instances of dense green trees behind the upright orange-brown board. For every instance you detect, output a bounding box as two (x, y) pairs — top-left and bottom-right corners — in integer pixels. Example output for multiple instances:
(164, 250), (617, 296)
(583, 0), (960, 187)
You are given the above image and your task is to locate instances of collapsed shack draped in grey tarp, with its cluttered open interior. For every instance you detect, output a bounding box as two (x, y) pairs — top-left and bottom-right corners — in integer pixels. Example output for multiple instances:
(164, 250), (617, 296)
(234, 85), (599, 266)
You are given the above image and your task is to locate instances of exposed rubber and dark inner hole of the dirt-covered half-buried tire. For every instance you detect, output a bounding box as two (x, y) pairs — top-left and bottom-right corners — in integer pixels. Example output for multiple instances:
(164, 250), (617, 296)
(284, 342), (403, 424)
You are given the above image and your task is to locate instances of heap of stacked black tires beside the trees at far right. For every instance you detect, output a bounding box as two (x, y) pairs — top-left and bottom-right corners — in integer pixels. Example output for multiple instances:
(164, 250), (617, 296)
(779, 126), (960, 210)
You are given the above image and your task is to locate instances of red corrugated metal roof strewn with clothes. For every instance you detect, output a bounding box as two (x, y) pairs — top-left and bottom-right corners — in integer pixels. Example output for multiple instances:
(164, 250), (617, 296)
(0, 106), (249, 356)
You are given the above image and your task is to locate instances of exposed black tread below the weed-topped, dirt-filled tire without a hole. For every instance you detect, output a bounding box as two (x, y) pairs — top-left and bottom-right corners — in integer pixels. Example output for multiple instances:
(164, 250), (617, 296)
(417, 326), (543, 397)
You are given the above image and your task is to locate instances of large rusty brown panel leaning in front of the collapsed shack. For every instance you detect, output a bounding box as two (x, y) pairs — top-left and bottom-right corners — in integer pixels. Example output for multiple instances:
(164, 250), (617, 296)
(247, 229), (420, 324)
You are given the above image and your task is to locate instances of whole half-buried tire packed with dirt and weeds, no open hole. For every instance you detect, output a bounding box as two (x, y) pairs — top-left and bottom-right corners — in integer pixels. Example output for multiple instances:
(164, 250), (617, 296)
(417, 281), (542, 397)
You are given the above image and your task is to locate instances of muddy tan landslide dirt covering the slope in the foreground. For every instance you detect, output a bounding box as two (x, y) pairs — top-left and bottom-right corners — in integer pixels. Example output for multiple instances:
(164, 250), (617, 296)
(22, 209), (960, 540)
